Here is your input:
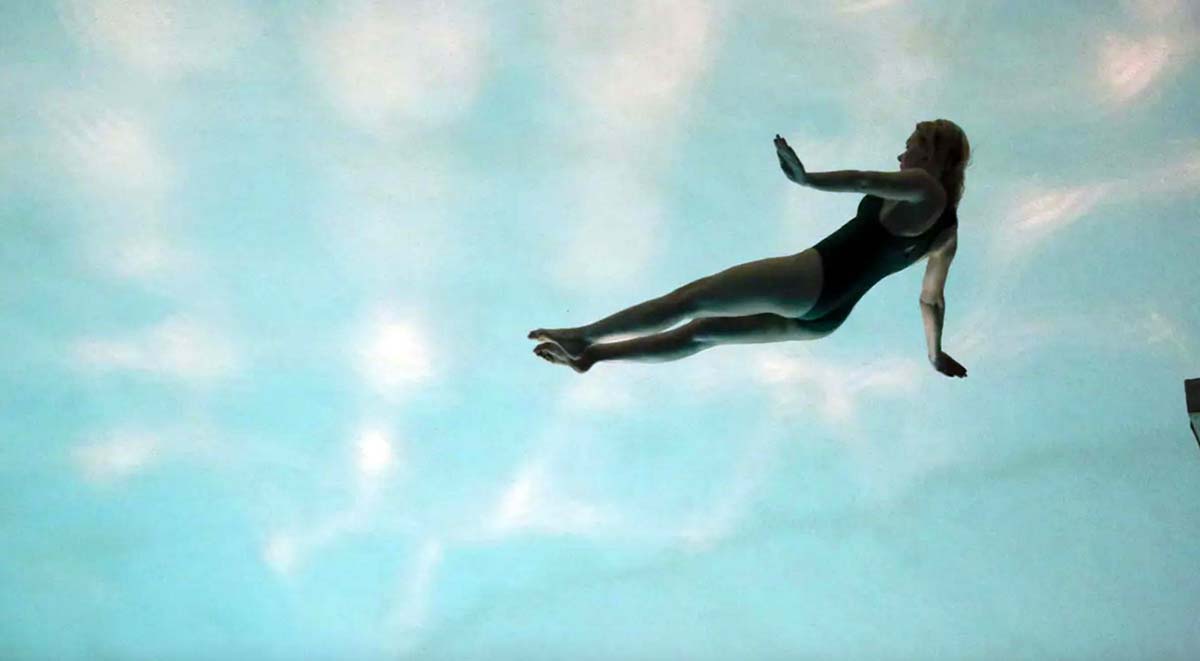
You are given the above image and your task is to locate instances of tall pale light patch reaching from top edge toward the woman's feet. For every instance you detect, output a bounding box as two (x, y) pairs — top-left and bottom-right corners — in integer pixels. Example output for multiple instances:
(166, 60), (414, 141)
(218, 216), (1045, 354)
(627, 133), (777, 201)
(542, 0), (719, 294)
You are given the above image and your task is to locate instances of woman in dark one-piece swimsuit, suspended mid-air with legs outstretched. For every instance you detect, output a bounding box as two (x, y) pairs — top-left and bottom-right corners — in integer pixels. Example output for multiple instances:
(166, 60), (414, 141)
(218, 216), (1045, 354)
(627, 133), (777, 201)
(529, 119), (971, 377)
